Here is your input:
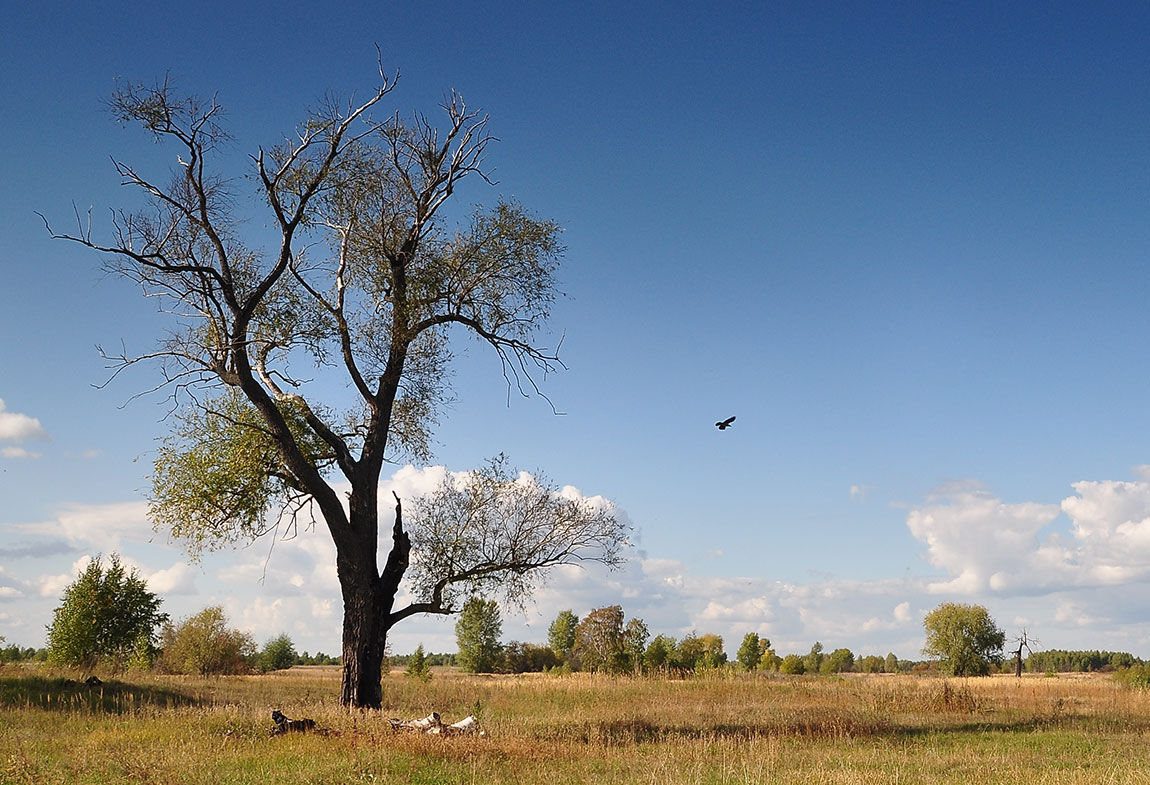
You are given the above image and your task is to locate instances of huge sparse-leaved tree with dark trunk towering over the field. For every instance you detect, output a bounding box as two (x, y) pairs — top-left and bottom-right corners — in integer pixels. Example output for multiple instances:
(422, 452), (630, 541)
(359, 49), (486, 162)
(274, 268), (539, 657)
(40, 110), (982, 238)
(45, 67), (626, 707)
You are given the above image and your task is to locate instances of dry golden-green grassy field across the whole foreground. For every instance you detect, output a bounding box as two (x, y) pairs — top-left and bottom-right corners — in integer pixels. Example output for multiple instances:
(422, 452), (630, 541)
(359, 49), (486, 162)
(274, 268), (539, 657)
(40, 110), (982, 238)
(0, 667), (1150, 785)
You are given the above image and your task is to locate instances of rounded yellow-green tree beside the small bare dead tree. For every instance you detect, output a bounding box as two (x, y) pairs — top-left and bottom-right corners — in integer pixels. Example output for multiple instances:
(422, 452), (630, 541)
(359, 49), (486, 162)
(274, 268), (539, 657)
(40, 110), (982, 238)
(922, 602), (1006, 676)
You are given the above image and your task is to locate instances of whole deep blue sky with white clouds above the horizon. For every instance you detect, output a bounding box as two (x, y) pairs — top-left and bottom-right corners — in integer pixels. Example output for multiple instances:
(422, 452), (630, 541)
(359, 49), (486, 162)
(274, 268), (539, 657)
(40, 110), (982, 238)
(0, 2), (1150, 657)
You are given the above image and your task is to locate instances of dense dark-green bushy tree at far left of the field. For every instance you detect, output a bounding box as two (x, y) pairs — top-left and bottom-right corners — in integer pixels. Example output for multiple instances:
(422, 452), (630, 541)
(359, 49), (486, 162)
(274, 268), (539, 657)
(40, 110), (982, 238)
(48, 554), (168, 669)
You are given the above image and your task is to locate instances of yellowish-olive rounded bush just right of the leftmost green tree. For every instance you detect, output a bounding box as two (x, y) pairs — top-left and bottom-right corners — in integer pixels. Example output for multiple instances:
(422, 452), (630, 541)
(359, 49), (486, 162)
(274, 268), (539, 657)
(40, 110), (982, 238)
(160, 606), (255, 676)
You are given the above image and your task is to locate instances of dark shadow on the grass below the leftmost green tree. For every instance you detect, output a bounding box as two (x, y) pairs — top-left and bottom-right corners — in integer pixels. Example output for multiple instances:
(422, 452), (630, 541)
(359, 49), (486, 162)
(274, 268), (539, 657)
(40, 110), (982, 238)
(0, 676), (202, 714)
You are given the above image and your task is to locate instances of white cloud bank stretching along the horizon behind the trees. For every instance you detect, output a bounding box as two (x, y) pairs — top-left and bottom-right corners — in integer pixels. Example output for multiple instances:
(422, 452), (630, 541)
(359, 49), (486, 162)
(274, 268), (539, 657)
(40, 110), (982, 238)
(0, 467), (1150, 657)
